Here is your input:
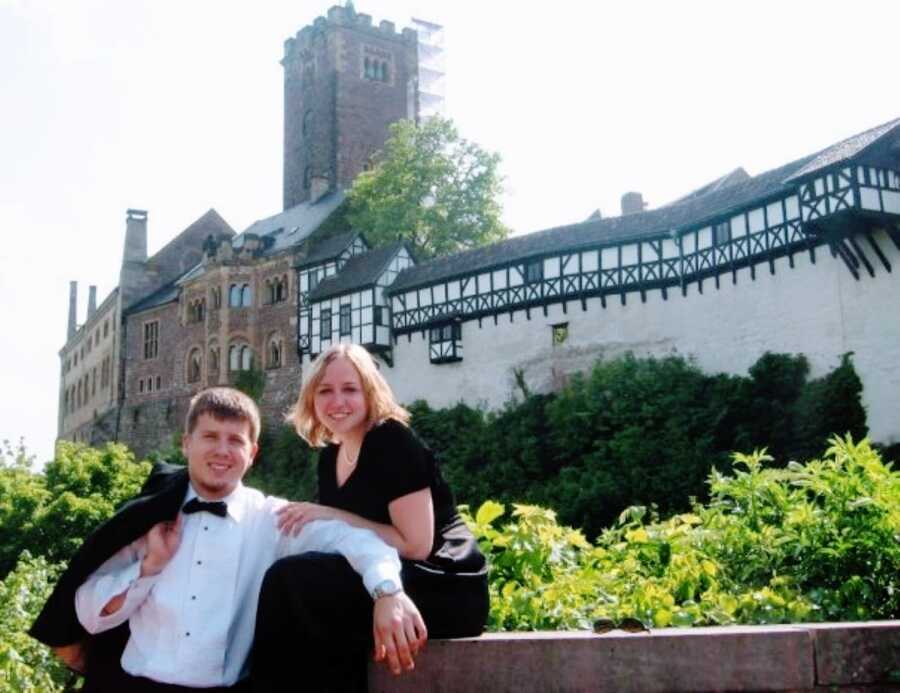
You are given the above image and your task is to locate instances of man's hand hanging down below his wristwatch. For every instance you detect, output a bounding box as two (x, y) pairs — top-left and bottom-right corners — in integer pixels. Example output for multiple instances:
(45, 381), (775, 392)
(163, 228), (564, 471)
(372, 592), (428, 674)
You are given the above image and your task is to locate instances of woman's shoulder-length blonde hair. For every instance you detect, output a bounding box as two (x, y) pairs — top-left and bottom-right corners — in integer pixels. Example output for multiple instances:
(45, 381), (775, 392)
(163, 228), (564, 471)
(285, 343), (410, 447)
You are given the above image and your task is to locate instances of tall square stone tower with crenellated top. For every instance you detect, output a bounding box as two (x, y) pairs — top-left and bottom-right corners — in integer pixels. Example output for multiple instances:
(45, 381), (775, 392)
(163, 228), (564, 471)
(281, 6), (418, 209)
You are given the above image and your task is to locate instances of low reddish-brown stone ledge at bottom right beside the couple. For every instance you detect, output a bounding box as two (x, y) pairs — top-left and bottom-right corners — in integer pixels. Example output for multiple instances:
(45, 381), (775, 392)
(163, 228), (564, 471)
(369, 621), (900, 693)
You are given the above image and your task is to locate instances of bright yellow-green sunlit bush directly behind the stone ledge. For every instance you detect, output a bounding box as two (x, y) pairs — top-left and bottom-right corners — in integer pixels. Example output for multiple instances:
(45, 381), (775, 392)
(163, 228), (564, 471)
(466, 437), (900, 630)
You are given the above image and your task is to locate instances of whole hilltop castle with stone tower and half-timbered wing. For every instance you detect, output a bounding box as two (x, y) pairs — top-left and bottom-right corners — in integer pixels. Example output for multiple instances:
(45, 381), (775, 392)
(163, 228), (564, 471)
(58, 7), (900, 454)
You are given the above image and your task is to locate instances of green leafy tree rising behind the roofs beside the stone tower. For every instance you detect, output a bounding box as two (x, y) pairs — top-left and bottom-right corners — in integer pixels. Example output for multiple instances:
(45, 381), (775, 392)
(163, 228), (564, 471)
(348, 117), (508, 258)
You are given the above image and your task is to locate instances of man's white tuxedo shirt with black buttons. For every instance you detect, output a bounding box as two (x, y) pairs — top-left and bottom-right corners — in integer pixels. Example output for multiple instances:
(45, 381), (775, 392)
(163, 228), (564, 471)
(75, 484), (400, 688)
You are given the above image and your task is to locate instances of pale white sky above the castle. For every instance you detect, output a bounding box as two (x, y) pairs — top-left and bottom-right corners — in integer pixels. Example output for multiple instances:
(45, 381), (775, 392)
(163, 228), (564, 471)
(0, 0), (900, 462)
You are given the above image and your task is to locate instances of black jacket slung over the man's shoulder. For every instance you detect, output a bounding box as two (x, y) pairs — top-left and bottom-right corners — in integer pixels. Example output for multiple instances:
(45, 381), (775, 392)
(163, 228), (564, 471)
(28, 462), (188, 647)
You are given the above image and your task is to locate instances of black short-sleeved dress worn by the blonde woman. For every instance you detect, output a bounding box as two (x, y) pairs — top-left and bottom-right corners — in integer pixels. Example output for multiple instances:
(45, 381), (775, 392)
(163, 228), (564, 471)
(251, 420), (488, 692)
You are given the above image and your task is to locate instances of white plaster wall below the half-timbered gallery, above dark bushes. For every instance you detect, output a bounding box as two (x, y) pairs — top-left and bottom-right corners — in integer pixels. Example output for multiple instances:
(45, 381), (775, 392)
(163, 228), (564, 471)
(383, 232), (900, 443)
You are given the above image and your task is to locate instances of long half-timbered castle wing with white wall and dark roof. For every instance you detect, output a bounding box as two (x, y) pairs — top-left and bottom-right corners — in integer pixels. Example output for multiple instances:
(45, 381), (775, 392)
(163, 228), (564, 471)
(311, 120), (900, 441)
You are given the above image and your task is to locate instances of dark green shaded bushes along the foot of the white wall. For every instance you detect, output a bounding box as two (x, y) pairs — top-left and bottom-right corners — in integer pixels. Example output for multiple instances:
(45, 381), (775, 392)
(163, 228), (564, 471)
(418, 354), (866, 538)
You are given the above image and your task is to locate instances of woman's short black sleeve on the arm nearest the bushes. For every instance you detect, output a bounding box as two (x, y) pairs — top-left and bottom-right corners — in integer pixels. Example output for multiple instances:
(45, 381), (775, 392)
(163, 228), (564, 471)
(376, 420), (433, 503)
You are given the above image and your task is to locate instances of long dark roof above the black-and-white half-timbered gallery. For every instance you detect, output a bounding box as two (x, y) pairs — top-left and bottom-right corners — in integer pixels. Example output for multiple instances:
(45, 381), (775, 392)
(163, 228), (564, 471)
(388, 119), (900, 294)
